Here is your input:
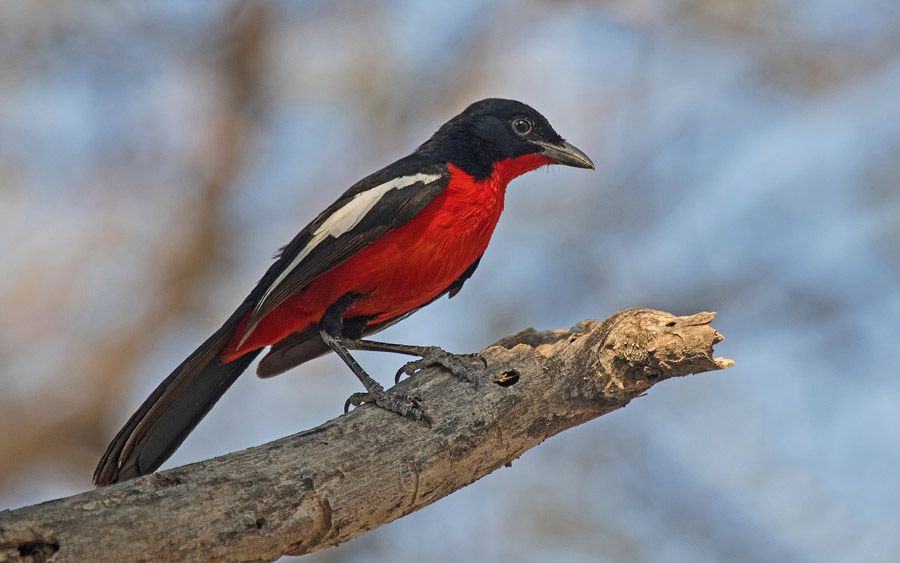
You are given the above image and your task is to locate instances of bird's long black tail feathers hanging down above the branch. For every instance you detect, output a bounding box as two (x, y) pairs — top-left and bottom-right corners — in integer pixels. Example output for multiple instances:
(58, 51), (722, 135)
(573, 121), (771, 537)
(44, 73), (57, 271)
(94, 306), (260, 487)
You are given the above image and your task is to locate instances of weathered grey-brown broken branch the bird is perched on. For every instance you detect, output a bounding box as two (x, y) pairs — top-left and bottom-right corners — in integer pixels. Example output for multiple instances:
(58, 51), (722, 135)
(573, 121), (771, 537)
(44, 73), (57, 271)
(0, 309), (733, 563)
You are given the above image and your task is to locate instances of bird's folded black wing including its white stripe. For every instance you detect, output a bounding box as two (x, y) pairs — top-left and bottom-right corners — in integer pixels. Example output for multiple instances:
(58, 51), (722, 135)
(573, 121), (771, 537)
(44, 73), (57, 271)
(244, 157), (450, 344)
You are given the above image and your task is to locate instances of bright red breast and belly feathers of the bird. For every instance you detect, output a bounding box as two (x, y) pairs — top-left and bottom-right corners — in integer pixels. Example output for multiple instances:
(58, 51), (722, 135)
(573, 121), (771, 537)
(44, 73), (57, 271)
(222, 166), (505, 362)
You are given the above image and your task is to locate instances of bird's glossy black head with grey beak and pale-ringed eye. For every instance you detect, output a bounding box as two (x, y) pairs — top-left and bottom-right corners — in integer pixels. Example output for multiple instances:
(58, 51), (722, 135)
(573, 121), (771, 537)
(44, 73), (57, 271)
(417, 98), (594, 180)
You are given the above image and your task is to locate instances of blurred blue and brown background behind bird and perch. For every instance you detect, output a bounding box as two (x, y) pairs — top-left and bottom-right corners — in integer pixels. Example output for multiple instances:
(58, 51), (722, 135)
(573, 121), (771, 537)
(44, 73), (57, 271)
(0, 0), (900, 563)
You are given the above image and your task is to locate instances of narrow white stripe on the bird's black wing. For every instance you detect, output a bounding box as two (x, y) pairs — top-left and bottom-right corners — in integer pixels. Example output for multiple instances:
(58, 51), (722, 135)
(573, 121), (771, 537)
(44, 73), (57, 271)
(256, 174), (441, 309)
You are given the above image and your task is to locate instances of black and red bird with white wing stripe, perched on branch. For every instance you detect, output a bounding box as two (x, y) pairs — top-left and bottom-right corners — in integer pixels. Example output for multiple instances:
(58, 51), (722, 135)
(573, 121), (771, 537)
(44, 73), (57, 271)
(93, 98), (594, 487)
